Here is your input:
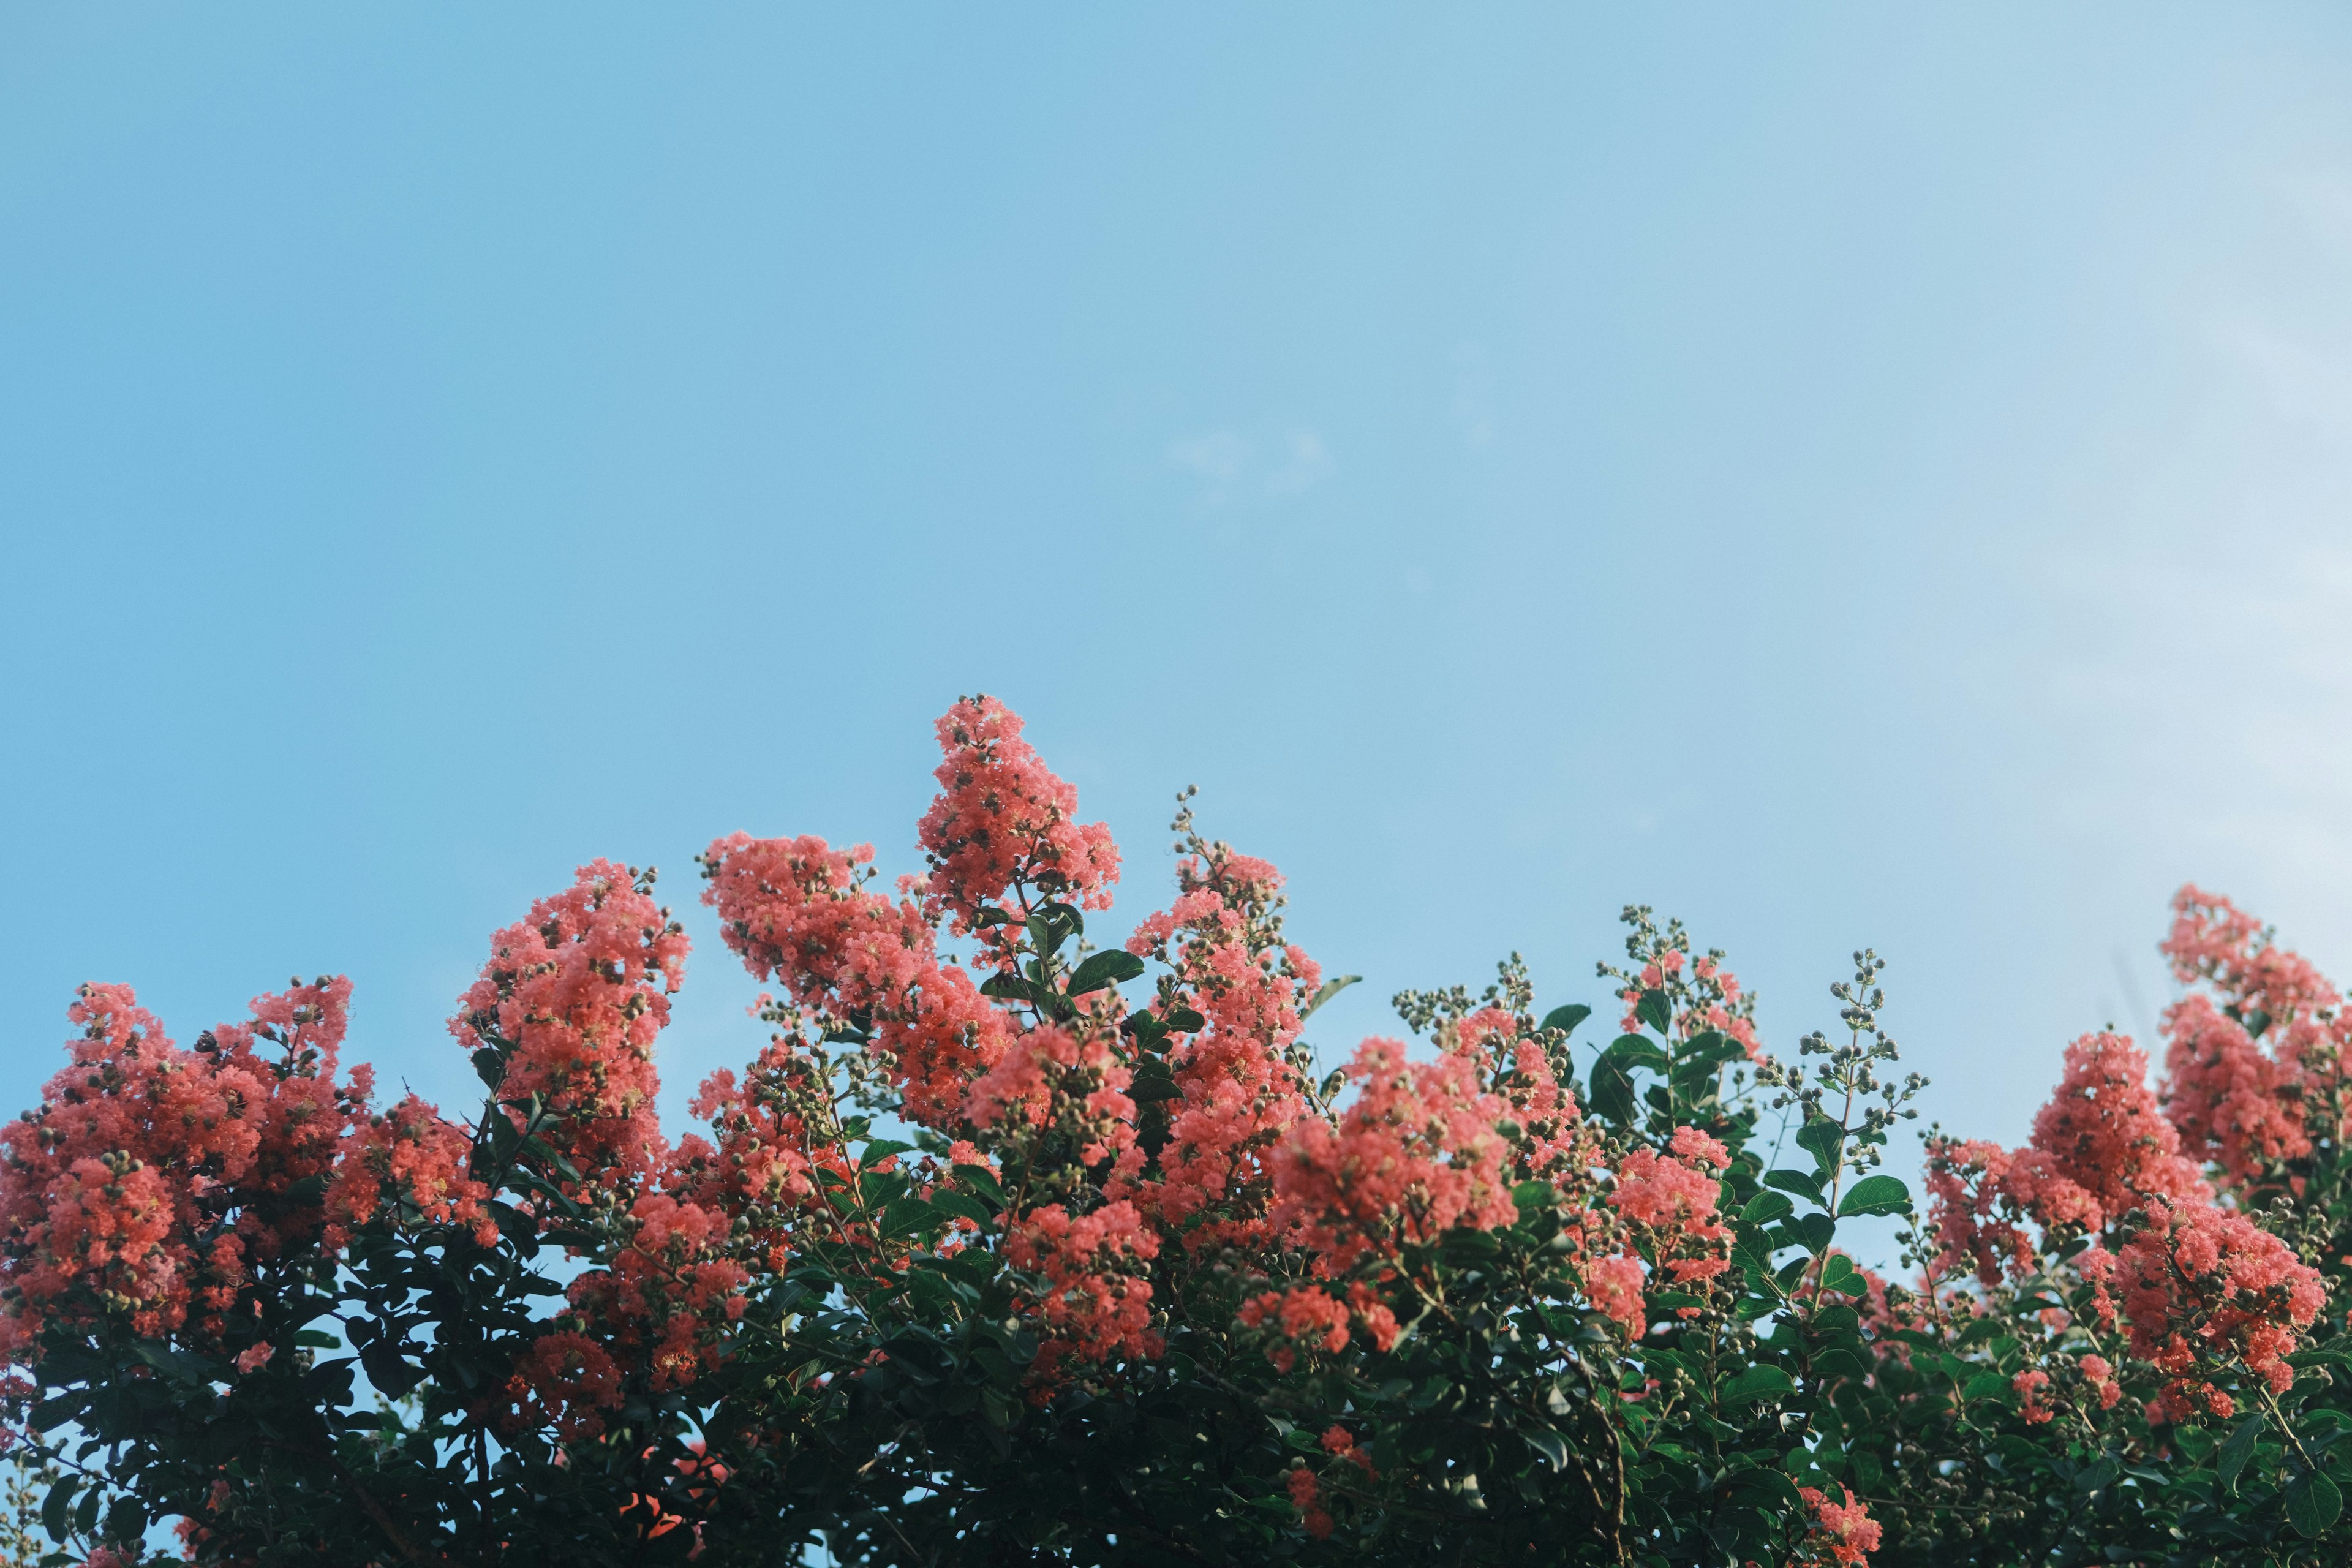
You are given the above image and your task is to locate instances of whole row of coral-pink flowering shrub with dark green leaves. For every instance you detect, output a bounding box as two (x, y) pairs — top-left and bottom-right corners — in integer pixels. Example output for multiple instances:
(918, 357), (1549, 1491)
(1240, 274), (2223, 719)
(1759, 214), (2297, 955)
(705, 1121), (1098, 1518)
(13, 698), (2352, 1568)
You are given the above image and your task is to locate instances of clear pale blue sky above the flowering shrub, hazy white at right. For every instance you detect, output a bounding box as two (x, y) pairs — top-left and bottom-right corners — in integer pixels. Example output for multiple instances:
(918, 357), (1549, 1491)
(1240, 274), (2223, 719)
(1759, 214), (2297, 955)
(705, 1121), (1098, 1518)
(0, 5), (2352, 1222)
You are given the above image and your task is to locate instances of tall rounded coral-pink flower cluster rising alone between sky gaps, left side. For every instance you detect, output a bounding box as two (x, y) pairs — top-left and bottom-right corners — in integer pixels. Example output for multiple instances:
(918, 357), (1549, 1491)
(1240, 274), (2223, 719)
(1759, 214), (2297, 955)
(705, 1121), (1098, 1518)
(449, 861), (687, 1185)
